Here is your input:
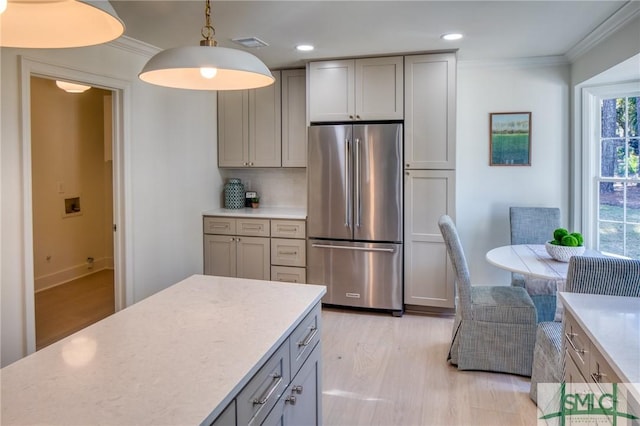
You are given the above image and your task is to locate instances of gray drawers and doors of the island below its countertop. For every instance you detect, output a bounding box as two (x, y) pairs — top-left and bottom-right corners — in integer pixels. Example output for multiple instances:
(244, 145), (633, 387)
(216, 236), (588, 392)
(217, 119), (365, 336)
(212, 304), (322, 426)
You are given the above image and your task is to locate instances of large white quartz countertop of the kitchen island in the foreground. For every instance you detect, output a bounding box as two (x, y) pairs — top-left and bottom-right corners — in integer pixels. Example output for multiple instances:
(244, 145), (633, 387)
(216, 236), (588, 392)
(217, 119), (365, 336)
(0, 275), (326, 425)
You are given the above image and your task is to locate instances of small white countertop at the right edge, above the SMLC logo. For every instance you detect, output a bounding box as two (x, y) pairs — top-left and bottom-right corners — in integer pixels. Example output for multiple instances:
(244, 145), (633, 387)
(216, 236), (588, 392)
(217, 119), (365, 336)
(559, 292), (640, 401)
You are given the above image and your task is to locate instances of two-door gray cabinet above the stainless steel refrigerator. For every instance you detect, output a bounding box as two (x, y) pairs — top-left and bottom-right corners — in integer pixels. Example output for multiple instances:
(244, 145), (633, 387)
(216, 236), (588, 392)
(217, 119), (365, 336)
(308, 56), (404, 122)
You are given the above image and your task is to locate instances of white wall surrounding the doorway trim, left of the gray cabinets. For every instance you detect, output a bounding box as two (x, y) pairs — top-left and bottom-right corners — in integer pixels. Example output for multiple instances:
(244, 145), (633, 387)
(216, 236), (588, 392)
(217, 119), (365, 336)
(0, 40), (221, 366)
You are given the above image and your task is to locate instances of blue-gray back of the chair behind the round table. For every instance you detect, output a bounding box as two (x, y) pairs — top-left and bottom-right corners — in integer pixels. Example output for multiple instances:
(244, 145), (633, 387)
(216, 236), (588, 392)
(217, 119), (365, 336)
(509, 207), (560, 244)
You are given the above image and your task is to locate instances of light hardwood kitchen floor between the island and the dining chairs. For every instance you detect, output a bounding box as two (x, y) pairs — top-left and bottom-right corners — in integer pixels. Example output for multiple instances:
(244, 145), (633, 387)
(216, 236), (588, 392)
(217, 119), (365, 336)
(322, 308), (537, 426)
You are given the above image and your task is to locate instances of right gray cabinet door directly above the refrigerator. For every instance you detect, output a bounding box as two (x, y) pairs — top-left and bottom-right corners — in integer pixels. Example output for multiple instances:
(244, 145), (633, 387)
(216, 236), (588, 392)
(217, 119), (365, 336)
(355, 56), (404, 120)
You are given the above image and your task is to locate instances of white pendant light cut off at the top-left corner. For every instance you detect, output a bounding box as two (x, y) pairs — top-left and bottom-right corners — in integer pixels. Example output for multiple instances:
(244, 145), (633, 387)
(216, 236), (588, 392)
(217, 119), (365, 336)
(0, 0), (124, 49)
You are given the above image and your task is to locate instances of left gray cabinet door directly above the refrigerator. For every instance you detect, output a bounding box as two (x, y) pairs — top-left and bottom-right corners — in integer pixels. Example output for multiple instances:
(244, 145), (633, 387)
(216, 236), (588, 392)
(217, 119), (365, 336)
(308, 59), (355, 122)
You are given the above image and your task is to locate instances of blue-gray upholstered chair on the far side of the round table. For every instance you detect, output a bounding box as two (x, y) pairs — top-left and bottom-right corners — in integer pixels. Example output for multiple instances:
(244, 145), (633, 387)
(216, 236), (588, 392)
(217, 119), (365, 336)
(509, 207), (561, 322)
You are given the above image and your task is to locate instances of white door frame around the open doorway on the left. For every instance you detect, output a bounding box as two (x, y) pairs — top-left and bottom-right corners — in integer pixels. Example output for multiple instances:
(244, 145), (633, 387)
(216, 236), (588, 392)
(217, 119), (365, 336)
(19, 56), (133, 354)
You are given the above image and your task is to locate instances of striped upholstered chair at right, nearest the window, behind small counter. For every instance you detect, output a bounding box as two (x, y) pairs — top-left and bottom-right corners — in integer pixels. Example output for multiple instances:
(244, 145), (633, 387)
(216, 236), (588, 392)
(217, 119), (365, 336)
(529, 256), (640, 402)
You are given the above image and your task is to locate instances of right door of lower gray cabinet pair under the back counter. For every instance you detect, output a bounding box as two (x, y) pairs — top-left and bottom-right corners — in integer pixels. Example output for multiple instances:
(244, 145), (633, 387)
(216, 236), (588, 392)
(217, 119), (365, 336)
(236, 237), (271, 280)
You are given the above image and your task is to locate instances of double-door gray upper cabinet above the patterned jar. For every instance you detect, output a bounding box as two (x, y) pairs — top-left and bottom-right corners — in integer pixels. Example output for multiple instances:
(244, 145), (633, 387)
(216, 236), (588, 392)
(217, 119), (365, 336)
(218, 71), (282, 167)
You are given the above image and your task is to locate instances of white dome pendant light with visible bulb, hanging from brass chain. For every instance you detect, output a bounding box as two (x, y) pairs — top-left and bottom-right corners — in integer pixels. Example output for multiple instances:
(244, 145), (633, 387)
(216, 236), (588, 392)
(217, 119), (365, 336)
(139, 0), (275, 90)
